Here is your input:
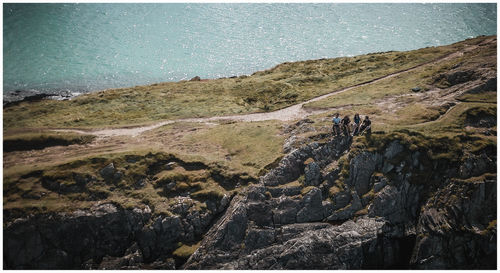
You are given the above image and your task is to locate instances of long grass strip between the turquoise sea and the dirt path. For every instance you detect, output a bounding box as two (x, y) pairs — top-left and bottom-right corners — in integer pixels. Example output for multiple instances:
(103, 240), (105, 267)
(3, 38), (484, 129)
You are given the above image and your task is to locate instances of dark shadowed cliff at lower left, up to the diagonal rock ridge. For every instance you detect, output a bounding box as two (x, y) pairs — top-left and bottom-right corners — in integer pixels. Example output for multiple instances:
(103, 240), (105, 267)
(4, 193), (230, 269)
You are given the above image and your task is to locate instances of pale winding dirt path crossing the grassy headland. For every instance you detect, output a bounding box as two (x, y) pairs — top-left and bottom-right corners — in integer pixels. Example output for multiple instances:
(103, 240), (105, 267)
(57, 39), (492, 137)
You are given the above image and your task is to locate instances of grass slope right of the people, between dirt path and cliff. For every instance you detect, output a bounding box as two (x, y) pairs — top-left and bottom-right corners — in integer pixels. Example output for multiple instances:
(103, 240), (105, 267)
(304, 35), (496, 138)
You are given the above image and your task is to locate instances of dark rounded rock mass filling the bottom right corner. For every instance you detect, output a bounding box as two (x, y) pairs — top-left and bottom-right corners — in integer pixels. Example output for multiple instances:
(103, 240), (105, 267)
(411, 178), (497, 269)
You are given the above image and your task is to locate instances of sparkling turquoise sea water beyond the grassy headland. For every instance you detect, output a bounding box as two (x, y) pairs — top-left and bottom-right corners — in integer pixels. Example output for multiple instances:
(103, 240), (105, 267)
(3, 3), (497, 98)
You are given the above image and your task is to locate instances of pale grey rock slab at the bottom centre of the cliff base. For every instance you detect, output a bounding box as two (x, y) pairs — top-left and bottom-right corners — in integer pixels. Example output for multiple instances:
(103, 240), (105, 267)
(186, 219), (384, 269)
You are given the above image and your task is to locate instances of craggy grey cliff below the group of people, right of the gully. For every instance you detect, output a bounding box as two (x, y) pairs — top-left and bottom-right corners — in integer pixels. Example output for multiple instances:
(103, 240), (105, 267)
(185, 134), (496, 269)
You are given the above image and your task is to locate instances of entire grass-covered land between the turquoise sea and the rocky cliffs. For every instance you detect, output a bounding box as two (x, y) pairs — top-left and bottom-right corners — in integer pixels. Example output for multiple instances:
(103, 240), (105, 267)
(3, 34), (497, 221)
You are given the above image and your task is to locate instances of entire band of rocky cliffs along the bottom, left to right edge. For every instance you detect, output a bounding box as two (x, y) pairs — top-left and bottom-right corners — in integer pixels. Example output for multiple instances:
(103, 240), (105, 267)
(4, 133), (496, 269)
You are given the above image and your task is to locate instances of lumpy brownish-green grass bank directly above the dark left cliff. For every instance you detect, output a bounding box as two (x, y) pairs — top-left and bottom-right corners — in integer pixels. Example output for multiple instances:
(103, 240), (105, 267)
(3, 150), (234, 219)
